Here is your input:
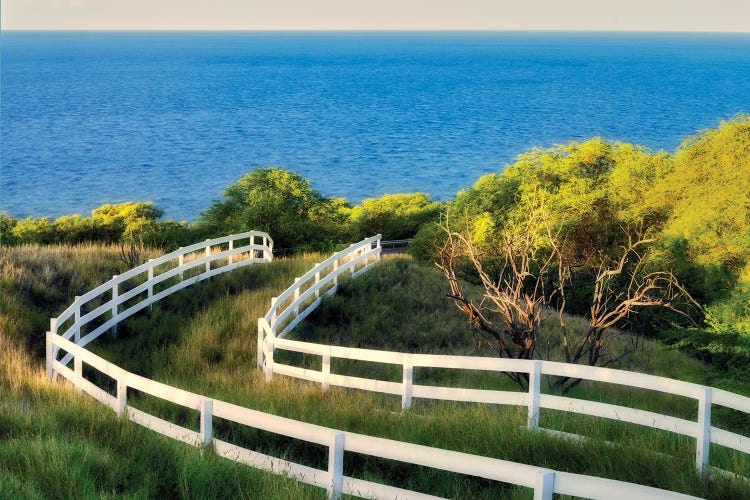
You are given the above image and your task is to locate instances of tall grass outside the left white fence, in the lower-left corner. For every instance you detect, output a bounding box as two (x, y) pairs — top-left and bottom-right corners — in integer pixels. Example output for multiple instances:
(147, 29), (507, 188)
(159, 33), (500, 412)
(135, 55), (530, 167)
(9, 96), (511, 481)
(0, 245), (324, 499)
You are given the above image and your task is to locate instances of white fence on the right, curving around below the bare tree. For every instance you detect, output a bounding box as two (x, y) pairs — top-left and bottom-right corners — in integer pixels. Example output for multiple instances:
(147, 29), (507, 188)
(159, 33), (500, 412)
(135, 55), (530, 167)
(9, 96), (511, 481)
(258, 236), (750, 496)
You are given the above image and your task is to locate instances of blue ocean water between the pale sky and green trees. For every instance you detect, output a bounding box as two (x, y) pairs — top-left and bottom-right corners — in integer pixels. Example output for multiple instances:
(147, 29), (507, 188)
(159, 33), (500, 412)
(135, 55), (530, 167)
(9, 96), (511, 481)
(0, 32), (750, 220)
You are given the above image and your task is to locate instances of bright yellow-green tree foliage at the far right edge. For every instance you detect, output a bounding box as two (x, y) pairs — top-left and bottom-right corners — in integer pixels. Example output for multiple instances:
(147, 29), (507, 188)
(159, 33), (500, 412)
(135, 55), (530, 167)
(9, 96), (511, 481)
(653, 115), (750, 333)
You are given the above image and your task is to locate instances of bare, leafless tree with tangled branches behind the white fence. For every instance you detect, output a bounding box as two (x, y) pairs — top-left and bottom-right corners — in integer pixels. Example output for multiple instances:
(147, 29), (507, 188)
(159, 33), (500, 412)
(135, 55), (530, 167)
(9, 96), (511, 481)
(436, 208), (700, 392)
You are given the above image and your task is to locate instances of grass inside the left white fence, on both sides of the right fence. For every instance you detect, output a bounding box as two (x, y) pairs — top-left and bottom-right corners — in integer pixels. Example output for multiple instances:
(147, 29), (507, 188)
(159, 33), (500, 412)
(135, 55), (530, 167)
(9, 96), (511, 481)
(91, 255), (750, 498)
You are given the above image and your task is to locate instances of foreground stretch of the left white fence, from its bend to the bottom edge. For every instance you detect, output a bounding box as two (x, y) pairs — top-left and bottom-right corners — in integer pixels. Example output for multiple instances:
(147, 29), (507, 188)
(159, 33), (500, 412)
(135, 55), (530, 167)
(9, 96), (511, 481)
(47, 324), (694, 500)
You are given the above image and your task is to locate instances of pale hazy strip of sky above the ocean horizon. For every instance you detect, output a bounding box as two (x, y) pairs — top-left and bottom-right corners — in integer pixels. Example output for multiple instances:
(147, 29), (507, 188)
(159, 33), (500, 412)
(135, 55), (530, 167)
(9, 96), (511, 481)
(0, 0), (750, 32)
